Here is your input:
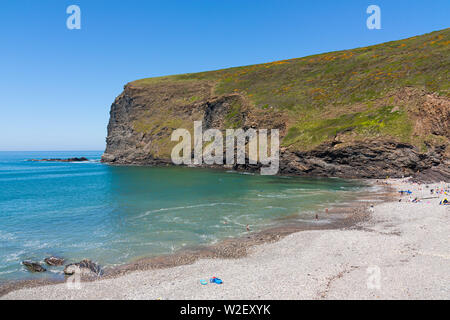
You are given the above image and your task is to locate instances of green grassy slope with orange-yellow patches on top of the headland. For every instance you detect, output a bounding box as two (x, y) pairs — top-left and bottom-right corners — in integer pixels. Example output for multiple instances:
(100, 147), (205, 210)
(132, 29), (450, 149)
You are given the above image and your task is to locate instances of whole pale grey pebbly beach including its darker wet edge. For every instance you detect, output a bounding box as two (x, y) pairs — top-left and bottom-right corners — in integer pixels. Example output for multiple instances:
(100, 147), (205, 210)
(2, 180), (450, 299)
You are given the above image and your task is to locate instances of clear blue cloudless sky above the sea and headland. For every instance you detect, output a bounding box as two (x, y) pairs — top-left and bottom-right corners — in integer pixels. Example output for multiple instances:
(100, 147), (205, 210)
(0, 0), (450, 151)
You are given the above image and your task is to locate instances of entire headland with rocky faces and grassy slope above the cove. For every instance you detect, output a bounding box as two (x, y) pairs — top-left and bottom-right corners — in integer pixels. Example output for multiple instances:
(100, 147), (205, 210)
(102, 29), (450, 179)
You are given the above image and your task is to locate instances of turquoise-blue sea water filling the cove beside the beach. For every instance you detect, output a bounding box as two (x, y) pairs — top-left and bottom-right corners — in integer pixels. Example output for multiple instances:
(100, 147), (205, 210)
(0, 152), (370, 281)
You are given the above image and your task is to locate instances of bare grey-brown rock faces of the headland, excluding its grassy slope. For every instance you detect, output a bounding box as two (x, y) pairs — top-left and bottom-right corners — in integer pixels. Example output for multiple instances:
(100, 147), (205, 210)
(103, 85), (450, 178)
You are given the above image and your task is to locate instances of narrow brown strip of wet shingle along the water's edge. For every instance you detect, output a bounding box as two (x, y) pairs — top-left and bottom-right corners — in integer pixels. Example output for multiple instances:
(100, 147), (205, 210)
(0, 179), (392, 298)
